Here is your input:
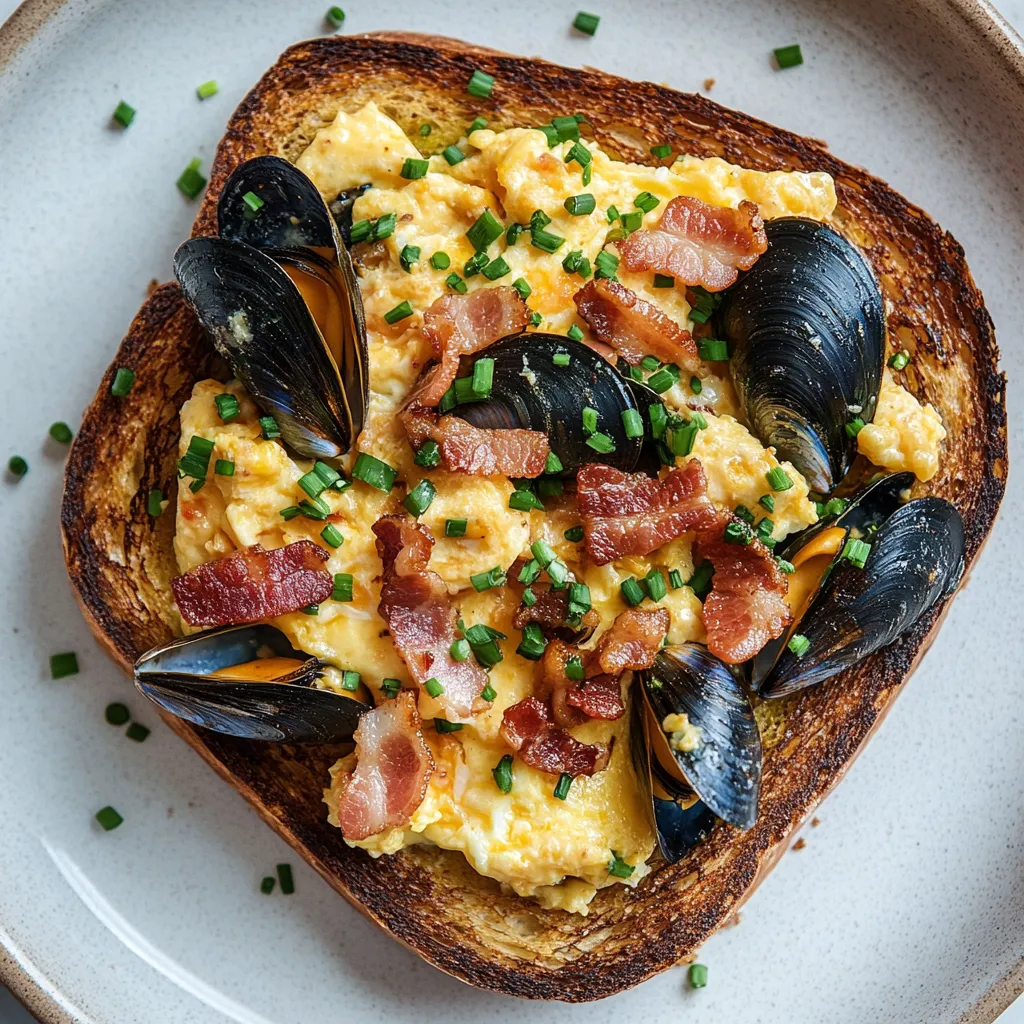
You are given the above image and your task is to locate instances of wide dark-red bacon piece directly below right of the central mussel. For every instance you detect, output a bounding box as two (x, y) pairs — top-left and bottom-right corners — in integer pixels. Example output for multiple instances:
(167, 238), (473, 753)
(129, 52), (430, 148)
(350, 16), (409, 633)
(577, 459), (717, 565)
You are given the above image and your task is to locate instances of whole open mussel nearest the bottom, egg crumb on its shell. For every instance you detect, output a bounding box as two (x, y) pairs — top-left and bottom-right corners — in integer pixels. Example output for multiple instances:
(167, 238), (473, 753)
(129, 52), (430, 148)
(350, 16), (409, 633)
(631, 643), (762, 862)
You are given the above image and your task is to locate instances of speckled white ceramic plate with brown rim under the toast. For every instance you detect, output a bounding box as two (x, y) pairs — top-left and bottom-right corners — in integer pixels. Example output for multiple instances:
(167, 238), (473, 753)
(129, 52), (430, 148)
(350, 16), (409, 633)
(0, 0), (1024, 1024)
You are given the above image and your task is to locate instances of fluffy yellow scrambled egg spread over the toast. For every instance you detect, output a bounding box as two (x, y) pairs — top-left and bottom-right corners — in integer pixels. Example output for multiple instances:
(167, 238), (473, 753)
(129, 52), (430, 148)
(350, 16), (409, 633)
(175, 103), (943, 913)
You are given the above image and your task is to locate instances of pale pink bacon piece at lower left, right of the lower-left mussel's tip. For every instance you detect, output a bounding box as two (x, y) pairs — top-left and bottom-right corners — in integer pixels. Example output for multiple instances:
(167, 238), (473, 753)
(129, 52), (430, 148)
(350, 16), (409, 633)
(338, 690), (434, 842)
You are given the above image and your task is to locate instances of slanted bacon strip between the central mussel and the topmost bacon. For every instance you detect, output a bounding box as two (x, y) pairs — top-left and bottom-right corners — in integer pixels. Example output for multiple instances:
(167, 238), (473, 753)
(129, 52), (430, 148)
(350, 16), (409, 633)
(573, 280), (700, 371)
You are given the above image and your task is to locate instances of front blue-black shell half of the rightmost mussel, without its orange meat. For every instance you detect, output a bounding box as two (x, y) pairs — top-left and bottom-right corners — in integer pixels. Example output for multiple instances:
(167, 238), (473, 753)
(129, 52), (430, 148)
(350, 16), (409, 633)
(759, 497), (965, 699)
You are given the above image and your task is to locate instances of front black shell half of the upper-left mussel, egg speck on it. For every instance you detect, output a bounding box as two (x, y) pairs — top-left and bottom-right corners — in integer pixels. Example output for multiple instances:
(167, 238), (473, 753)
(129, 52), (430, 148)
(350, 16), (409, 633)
(174, 239), (361, 459)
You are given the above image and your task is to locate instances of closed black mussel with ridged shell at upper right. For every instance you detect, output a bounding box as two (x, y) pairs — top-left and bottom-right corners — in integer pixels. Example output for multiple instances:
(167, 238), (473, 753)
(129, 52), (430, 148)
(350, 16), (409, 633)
(718, 217), (886, 494)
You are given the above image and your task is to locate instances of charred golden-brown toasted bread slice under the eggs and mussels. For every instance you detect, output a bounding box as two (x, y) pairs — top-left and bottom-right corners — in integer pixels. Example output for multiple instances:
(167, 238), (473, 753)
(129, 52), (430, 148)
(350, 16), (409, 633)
(61, 34), (1007, 1000)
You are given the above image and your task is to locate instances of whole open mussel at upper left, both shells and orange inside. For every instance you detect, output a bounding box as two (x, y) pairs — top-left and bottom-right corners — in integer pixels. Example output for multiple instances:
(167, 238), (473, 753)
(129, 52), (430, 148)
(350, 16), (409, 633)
(174, 157), (369, 459)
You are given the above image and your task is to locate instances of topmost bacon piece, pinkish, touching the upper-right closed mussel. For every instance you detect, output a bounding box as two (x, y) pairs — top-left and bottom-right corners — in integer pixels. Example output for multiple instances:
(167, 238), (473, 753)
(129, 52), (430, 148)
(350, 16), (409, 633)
(618, 196), (768, 292)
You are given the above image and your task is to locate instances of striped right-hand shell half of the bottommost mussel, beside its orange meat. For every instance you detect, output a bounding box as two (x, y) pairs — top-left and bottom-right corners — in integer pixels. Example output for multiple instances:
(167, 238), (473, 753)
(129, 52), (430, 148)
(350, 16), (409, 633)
(638, 643), (761, 828)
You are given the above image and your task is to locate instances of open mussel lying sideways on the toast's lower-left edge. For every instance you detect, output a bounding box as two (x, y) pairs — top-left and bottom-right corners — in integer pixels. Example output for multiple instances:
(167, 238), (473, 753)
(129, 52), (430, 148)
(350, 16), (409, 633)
(134, 626), (372, 743)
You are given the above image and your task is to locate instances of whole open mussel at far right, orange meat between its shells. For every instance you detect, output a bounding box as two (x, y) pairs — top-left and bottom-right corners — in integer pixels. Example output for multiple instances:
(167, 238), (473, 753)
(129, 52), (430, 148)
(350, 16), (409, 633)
(751, 473), (965, 699)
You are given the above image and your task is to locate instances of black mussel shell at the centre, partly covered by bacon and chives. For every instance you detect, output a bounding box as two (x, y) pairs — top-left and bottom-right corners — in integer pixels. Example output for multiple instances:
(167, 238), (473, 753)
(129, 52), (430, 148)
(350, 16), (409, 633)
(453, 332), (653, 474)
